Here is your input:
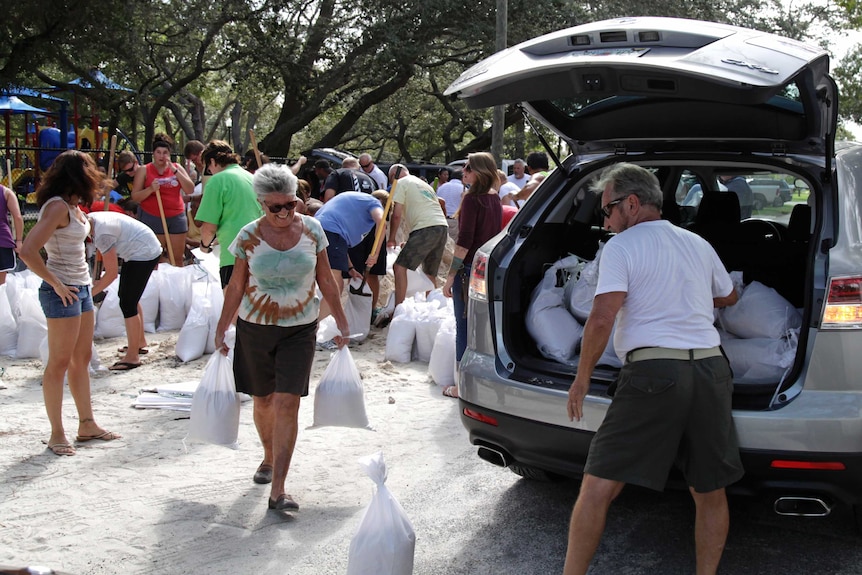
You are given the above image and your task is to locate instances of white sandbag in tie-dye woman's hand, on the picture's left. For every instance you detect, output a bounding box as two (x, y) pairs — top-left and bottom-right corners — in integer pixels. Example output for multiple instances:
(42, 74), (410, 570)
(183, 334), (240, 449)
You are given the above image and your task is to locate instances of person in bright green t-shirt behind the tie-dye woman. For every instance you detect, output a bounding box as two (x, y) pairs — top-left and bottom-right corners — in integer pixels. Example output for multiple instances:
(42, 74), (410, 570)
(195, 140), (263, 288)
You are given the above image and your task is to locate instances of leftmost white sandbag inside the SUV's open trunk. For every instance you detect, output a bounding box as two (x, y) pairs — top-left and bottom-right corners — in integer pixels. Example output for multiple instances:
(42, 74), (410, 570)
(524, 256), (584, 362)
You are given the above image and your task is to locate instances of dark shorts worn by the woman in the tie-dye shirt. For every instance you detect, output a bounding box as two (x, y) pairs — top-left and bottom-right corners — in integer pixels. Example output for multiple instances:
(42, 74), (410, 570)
(233, 318), (317, 397)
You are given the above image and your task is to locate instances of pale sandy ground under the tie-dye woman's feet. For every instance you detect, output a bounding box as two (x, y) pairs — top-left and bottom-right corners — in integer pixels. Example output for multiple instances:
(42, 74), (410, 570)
(0, 318), (475, 575)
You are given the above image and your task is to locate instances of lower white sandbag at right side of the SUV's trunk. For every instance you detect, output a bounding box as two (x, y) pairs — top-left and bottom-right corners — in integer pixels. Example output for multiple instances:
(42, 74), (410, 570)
(721, 330), (799, 383)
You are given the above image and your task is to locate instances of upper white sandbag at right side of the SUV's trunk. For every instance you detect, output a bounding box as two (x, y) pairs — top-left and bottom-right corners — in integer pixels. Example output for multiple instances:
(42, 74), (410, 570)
(719, 282), (802, 339)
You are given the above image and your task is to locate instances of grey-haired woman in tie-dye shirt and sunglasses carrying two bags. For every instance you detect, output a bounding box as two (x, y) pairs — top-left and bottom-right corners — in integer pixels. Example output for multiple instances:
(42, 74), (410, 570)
(215, 164), (349, 511)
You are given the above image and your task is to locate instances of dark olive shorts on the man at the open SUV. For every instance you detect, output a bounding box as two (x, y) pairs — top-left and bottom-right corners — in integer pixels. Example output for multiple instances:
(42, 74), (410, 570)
(584, 356), (743, 493)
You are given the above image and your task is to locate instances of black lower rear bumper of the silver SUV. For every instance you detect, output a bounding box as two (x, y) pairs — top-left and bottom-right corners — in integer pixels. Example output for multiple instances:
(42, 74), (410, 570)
(466, 399), (862, 505)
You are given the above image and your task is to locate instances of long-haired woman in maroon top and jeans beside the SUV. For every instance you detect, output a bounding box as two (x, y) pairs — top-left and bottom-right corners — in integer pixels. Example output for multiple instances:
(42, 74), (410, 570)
(443, 152), (503, 397)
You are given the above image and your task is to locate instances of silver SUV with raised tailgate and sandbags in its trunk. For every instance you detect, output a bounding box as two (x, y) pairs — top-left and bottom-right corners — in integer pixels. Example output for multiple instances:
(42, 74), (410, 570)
(447, 18), (862, 515)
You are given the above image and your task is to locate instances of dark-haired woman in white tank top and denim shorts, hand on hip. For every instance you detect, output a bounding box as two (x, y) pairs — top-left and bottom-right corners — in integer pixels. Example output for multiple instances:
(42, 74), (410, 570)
(19, 150), (120, 455)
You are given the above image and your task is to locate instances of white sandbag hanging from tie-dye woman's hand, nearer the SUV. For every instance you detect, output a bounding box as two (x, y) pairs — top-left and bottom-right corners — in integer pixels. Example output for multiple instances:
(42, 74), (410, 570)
(312, 346), (368, 428)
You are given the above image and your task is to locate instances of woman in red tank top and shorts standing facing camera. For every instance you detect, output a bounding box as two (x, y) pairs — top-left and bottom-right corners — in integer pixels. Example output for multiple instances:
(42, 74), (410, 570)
(131, 133), (195, 266)
